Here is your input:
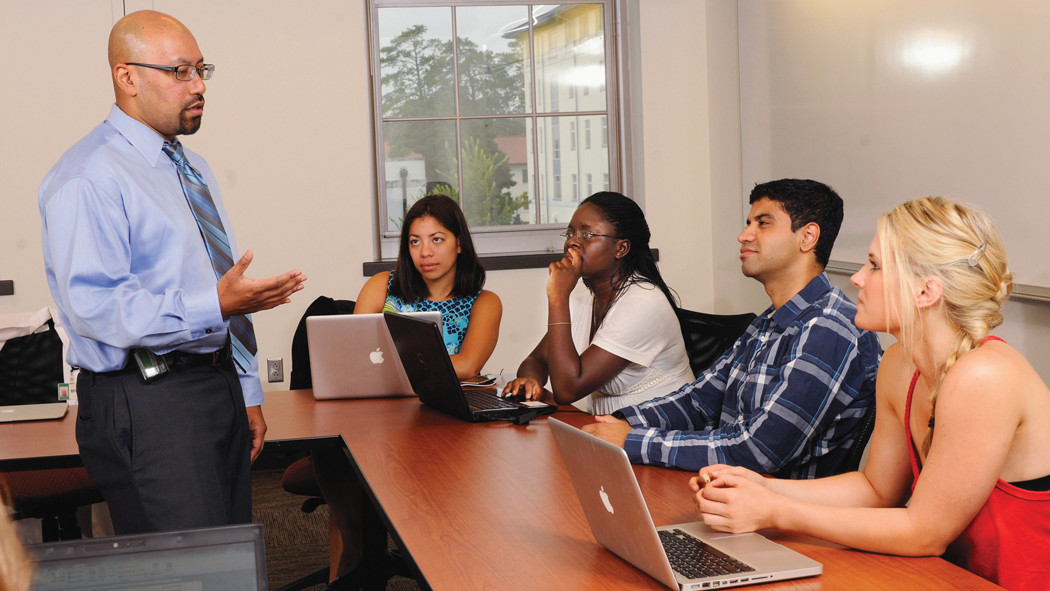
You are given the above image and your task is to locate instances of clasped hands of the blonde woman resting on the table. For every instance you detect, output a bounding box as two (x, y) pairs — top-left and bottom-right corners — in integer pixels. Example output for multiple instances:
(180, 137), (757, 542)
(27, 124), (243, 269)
(689, 464), (776, 533)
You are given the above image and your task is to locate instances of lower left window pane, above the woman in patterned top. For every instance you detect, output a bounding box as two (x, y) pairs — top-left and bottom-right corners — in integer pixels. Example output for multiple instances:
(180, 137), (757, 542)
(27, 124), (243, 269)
(383, 121), (459, 232)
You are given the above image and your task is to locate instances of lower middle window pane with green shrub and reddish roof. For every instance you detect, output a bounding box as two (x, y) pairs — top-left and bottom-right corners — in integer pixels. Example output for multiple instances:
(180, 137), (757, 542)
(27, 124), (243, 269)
(460, 119), (536, 227)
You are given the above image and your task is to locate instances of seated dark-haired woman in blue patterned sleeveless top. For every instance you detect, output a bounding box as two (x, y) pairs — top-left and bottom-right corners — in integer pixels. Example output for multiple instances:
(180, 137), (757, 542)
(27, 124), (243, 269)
(354, 195), (503, 379)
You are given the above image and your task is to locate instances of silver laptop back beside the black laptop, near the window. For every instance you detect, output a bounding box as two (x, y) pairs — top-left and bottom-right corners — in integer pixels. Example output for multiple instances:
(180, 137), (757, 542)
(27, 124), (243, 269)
(307, 312), (441, 400)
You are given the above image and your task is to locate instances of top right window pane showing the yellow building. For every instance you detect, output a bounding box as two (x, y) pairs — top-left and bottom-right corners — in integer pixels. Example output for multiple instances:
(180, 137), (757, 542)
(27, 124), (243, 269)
(524, 4), (606, 112)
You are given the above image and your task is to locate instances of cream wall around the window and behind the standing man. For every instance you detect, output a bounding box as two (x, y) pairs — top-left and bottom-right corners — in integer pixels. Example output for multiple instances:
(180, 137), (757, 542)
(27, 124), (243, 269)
(0, 0), (1050, 389)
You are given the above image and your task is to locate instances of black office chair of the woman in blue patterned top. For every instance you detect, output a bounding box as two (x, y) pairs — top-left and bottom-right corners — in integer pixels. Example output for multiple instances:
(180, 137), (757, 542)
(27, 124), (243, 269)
(277, 296), (354, 591)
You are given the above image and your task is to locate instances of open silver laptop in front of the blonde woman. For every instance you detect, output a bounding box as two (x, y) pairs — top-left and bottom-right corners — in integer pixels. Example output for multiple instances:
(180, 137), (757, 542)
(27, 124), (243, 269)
(547, 418), (823, 591)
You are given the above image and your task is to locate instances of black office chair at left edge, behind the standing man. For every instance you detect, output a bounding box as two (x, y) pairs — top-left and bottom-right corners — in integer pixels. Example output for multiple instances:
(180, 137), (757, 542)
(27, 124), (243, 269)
(0, 319), (103, 542)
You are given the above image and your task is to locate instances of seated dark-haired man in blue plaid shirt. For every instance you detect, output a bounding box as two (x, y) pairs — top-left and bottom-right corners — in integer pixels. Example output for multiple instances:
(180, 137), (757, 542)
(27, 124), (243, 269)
(584, 178), (882, 479)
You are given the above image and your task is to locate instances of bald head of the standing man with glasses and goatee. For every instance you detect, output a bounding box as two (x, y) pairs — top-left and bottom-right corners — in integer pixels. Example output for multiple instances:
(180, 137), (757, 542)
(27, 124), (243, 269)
(109, 10), (206, 140)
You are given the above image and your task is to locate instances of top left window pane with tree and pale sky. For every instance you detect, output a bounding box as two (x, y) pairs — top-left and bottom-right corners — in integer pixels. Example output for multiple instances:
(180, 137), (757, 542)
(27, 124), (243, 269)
(379, 7), (456, 118)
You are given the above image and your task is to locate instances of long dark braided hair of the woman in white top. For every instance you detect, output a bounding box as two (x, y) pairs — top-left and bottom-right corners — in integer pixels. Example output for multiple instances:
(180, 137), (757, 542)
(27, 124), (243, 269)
(580, 191), (678, 309)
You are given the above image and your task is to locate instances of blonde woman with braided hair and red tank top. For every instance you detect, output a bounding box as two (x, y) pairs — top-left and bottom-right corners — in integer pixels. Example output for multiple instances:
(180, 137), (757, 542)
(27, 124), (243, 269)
(690, 197), (1050, 590)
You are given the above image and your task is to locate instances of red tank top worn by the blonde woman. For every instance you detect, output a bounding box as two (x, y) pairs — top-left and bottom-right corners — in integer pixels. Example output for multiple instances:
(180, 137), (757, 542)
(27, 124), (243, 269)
(904, 337), (1050, 591)
